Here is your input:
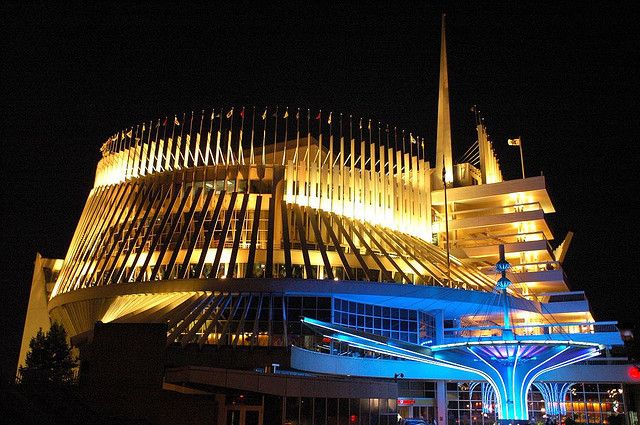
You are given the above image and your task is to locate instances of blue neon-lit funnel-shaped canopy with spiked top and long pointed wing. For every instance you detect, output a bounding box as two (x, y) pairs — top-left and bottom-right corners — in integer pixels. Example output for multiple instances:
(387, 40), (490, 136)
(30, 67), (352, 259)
(302, 245), (604, 423)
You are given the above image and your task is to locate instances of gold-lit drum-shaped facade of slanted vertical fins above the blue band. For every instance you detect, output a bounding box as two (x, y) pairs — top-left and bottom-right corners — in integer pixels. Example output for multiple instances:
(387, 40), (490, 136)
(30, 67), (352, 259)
(52, 109), (493, 297)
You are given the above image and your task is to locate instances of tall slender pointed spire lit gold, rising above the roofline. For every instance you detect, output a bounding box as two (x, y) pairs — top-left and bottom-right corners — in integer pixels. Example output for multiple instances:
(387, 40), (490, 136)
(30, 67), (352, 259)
(432, 13), (453, 189)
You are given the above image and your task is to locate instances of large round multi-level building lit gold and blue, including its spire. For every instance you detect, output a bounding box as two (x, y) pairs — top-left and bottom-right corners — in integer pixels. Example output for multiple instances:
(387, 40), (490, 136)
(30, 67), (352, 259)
(20, 17), (639, 425)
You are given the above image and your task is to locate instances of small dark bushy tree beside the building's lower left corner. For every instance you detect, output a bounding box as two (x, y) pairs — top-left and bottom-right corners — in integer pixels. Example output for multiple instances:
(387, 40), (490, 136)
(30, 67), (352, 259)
(20, 322), (77, 385)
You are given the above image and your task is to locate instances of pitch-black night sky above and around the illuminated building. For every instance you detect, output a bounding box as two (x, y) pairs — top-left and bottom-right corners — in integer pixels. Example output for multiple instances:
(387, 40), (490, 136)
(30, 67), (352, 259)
(0, 1), (640, 377)
